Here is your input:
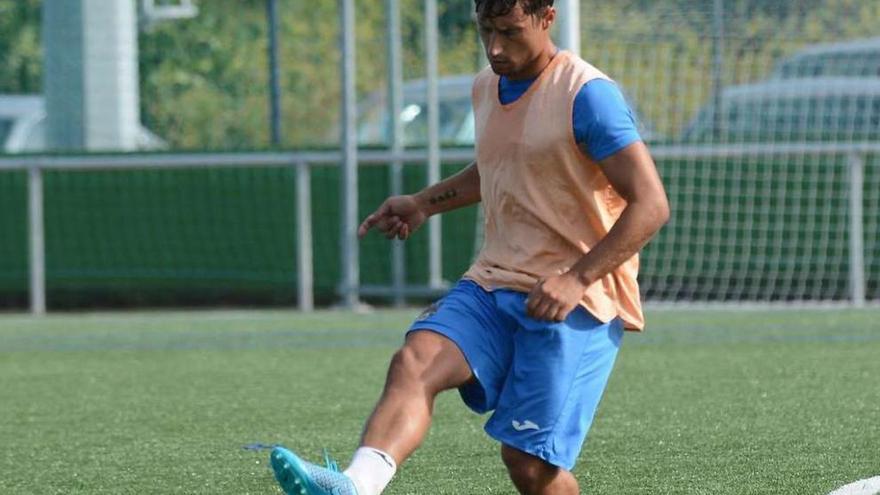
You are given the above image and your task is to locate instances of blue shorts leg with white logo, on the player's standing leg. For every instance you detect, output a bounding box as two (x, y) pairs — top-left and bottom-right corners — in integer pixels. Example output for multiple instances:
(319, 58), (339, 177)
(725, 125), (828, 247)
(486, 301), (623, 470)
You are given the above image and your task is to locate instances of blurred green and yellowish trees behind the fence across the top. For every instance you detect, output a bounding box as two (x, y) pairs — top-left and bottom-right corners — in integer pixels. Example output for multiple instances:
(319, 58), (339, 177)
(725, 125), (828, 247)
(0, 0), (880, 149)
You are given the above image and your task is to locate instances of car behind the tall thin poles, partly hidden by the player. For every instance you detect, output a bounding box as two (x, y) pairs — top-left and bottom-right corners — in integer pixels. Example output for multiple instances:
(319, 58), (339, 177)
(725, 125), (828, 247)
(358, 74), (659, 146)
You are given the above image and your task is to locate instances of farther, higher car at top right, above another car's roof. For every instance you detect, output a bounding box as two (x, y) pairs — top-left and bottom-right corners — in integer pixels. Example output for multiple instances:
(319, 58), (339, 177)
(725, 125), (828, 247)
(770, 37), (880, 79)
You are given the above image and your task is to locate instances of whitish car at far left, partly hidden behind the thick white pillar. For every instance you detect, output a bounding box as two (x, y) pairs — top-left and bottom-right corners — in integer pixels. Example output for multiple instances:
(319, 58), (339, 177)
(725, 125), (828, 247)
(0, 95), (168, 153)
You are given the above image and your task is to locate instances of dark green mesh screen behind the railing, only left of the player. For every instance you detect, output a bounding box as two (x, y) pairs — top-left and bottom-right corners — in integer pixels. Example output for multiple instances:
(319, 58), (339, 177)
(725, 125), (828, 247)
(0, 161), (476, 308)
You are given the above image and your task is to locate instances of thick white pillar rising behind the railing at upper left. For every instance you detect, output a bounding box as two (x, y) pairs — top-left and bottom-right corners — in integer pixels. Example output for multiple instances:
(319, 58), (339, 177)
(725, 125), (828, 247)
(43, 0), (140, 151)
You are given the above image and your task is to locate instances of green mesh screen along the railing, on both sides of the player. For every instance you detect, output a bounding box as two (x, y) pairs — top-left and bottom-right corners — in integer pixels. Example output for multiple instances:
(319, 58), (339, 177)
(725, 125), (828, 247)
(0, 155), (880, 308)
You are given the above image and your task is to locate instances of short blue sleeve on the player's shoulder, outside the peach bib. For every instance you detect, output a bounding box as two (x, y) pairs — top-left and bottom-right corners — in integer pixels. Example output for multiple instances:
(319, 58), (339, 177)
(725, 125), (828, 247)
(572, 79), (641, 161)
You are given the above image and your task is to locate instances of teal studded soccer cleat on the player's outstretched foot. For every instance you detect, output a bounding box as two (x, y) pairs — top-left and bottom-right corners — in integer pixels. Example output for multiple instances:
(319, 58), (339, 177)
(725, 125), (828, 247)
(269, 447), (357, 495)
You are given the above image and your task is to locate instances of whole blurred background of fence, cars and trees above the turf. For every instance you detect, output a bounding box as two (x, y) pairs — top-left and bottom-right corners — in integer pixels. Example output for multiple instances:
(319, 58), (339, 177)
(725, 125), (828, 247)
(0, 0), (880, 313)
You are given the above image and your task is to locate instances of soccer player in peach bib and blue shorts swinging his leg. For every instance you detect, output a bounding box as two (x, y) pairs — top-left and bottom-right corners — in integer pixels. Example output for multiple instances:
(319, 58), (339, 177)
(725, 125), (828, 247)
(271, 0), (669, 495)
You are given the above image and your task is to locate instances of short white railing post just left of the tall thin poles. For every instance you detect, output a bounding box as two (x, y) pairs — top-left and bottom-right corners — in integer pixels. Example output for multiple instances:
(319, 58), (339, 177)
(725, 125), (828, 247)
(296, 162), (315, 311)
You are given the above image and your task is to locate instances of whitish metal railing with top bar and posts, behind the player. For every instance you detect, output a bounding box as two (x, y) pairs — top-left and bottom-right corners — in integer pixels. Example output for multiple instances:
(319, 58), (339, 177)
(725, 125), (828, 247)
(0, 143), (880, 314)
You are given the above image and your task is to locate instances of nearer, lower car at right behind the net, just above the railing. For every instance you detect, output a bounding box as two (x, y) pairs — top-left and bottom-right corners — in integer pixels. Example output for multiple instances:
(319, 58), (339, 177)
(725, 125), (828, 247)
(680, 77), (880, 143)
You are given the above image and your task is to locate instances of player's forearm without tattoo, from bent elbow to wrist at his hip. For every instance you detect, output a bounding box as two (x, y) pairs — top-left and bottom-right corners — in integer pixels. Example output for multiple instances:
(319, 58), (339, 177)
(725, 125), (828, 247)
(569, 203), (669, 286)
